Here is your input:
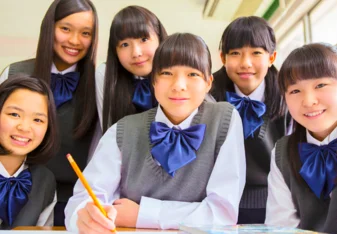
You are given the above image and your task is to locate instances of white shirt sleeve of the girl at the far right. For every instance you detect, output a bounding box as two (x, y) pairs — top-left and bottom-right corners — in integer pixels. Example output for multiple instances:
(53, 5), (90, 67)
(265, 148), (300, 227)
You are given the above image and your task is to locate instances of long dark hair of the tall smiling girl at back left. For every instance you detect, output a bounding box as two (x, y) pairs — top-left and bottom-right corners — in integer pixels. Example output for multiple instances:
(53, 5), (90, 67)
(33, 0), (98, 138)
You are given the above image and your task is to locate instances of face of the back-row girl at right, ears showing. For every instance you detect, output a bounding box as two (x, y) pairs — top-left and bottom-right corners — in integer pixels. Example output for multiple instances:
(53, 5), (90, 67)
(221, 46), (276, 95)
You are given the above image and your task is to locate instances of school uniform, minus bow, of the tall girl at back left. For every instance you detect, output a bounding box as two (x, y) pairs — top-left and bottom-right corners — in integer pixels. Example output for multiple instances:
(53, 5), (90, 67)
(0, 59), (102, 226)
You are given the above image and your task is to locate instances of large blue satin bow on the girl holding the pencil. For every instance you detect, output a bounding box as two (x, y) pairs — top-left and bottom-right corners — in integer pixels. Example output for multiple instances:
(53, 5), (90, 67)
(150, 122), (206, 177)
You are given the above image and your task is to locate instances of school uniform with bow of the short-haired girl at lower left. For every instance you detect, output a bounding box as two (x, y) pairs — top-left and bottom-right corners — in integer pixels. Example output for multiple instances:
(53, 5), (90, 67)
(0, 162), (56, 230)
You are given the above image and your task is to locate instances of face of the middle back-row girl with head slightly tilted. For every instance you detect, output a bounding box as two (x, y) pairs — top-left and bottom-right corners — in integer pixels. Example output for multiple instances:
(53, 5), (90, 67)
(116, 30), (159, 76)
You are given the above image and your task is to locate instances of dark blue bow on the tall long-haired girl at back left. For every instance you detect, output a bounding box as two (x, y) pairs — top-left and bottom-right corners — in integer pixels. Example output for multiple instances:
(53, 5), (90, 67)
(51, 72), (80, 108)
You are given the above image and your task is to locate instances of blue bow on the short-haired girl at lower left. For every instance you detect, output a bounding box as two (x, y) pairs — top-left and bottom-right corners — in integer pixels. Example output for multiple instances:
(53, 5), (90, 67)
(0, 169), (32, 226)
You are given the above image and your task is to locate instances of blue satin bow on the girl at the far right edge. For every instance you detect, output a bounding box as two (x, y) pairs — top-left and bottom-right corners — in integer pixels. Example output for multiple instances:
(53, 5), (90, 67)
(298, 139), (337, 198)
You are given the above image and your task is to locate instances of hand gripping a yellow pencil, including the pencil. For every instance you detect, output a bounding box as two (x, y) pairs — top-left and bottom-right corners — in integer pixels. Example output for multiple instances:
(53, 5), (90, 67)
(67, 154), (117, 233)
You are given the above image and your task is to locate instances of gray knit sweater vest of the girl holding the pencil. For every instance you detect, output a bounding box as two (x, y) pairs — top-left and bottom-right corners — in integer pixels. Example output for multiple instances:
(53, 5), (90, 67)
(117, 102), (233, 204)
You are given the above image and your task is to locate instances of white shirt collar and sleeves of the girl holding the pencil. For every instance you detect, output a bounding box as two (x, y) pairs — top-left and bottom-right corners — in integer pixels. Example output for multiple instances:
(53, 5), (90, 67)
(65, 107), (246, 231)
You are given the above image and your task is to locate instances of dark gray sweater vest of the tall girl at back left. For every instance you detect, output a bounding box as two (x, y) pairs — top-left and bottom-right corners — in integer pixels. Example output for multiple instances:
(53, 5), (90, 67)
(8, 59), (94, 202)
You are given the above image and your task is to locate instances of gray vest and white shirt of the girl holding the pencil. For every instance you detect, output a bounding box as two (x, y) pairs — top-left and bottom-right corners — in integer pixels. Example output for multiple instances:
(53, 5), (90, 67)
(65, 102), (246, 231)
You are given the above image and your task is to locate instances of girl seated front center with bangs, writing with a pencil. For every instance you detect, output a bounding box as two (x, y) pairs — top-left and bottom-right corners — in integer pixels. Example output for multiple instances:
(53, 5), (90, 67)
(65, 33), (246, 233)
